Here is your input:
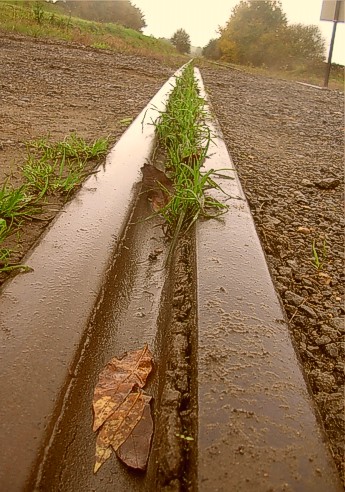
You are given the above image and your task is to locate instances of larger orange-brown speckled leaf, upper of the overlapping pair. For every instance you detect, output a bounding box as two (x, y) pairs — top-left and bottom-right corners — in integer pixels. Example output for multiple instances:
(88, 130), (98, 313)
(93, 344), (152, 431)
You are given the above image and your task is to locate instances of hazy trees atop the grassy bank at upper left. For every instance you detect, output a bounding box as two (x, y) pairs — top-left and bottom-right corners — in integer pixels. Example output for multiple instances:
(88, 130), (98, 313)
(58, 0), (146, 32)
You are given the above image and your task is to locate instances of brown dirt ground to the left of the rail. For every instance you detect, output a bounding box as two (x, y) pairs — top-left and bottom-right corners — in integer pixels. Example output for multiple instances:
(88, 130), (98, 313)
(0, 31), (177, 283)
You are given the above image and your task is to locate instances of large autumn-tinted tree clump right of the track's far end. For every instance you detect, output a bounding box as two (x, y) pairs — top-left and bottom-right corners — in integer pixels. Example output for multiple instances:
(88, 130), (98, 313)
(203, 0), (325, 69)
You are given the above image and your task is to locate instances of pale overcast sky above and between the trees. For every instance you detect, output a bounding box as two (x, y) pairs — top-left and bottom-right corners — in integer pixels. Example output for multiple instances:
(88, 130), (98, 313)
(132, 0), (345, 65)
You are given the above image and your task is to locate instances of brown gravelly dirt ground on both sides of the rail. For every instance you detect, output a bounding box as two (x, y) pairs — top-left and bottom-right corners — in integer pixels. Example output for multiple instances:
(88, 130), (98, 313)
(0, 33), (345, 486)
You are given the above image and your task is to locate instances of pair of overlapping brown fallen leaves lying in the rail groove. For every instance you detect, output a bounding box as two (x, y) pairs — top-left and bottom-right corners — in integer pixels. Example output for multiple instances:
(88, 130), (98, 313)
(93, 344), (153, 473)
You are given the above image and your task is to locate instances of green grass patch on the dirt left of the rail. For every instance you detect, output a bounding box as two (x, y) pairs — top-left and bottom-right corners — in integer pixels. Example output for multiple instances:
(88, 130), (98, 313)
(0, 133), (109, 273)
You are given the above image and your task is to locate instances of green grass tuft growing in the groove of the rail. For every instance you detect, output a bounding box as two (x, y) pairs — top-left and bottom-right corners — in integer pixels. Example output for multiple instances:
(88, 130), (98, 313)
(155, 65), (227, 247)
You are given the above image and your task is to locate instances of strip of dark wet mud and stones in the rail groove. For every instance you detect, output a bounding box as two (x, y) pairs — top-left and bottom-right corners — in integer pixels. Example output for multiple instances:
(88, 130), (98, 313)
(148, 233), (197, 492)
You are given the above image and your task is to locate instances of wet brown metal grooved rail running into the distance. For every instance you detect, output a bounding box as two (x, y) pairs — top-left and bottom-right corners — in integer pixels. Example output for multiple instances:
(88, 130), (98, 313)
(0, 66), (341, 492)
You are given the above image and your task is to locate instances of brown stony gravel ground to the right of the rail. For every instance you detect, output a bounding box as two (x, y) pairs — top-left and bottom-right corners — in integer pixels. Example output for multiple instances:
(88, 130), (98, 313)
(202, 69), (345, 486)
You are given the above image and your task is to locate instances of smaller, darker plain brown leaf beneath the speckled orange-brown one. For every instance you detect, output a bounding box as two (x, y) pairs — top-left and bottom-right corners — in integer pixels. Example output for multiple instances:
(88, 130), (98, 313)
(116, 395), (153, 471)
